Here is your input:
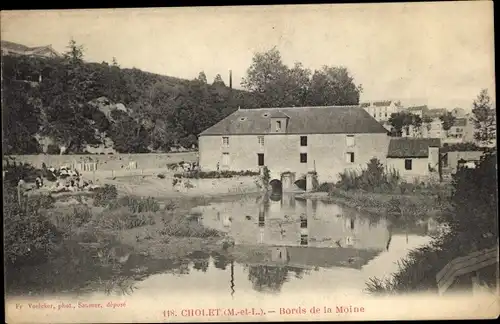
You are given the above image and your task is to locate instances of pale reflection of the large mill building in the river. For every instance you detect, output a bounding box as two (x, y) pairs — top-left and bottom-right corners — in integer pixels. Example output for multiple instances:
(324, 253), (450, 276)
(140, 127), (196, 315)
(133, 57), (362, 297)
(195, 194), (389, 250)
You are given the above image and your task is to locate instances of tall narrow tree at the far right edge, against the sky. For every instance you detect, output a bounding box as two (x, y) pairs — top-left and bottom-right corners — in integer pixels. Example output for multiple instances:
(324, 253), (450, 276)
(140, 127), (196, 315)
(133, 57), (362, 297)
(472, 89), (497, 145)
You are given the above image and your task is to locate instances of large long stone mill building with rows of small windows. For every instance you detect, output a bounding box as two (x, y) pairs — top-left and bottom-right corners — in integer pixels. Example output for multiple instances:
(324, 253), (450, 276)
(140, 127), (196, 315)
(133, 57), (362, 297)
(199, 106), (390, 189)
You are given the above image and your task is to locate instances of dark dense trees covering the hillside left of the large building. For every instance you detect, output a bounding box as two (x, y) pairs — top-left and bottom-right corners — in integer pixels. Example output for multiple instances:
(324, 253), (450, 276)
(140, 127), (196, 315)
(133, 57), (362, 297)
(2, 41), (259, 154)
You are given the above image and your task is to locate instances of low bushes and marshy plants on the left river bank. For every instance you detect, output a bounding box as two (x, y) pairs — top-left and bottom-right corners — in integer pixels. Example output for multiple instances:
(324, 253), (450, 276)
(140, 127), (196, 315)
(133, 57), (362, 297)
(4, 164), (246, 293)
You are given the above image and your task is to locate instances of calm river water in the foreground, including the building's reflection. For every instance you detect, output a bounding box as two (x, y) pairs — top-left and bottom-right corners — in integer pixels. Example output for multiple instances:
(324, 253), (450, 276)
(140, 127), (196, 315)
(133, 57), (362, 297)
(5, 195), (430, 298)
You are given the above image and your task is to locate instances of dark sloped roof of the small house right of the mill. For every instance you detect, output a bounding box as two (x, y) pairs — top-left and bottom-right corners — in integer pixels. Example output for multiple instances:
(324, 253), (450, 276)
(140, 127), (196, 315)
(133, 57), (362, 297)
(387, 137), (441, 158)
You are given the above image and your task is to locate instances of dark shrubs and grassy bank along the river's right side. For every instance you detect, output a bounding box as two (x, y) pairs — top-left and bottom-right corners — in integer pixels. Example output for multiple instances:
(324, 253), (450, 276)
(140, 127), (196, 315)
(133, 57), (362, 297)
(319, 154), (498, 294)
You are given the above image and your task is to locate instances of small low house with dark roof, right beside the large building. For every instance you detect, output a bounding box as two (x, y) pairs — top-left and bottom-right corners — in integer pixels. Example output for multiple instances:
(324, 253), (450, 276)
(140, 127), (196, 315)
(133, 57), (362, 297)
(387, 137), (441, 181)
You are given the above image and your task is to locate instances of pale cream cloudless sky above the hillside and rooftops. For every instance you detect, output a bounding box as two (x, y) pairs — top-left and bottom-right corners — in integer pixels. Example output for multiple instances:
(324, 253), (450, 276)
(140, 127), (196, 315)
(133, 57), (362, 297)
(1, 1), (495, 109)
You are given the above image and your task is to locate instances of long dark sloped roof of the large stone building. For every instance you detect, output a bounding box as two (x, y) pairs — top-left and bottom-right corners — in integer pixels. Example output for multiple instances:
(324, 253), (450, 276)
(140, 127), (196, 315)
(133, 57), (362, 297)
(200, 106), (387, 136)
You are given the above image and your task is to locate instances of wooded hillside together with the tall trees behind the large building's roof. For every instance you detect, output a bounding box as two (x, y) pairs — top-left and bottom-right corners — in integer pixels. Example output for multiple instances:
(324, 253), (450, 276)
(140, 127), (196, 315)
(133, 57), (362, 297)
(2, 41), (361, 154)
